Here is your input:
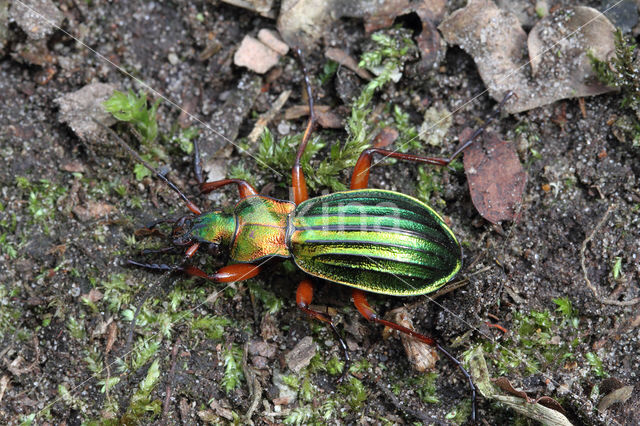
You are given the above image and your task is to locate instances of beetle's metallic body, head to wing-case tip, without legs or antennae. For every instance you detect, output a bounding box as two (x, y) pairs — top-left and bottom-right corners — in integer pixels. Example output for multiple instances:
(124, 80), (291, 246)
(183, 189), (462, 296)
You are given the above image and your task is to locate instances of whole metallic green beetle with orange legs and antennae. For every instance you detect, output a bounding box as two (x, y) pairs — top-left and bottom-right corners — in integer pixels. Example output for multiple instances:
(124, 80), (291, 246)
(106, 51), (513, 421)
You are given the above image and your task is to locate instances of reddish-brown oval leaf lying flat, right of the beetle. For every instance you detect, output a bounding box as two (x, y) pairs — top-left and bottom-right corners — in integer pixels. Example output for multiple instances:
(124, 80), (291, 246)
(460, 129), (527, 223)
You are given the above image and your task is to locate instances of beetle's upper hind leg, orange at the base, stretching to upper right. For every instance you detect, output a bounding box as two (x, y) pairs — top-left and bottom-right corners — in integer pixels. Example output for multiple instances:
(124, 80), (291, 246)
(351, 92), (514, 189)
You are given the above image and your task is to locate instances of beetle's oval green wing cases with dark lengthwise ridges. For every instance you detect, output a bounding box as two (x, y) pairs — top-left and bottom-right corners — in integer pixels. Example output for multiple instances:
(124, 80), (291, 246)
(288, 189), (462, 296)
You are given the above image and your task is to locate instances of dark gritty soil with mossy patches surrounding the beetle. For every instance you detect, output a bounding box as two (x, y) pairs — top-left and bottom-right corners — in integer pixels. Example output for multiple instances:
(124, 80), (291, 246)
(0, 0), (640, 425)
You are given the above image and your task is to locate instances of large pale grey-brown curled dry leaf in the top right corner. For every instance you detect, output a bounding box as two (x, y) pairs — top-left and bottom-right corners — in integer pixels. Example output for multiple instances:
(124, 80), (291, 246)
(438, 0), (614, 113)
